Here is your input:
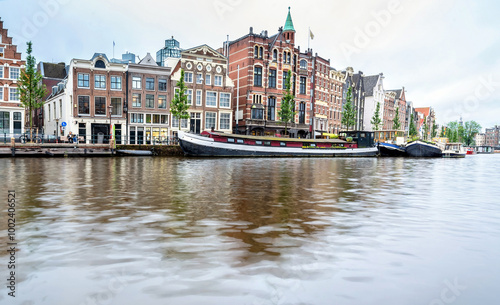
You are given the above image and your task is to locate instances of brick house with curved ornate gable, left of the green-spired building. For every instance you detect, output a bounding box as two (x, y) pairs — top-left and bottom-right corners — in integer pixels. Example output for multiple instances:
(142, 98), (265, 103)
(171, 45), (234, 135)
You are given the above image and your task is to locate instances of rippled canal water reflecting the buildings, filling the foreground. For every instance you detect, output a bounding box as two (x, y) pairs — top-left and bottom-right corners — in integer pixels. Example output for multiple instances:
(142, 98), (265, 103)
(0, 155), (500, 305)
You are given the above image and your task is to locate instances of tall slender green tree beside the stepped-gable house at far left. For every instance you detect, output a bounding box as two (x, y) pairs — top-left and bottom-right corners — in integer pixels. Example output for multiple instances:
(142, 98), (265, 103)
(19, 41), (47, 139)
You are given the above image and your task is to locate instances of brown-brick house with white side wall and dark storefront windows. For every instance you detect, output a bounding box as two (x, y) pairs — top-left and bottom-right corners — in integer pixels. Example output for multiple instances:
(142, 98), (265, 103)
(43, 53), (127, 144)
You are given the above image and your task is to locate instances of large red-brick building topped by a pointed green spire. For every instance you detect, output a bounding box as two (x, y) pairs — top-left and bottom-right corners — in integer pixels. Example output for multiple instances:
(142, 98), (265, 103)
(225, 11), (313, 137)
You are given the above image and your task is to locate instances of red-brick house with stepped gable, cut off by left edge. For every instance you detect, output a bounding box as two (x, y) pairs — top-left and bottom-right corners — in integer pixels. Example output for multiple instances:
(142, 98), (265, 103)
(0, 20), (26, 138)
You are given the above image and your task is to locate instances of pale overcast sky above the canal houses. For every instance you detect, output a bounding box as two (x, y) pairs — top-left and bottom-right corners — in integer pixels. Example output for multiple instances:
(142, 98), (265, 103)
(0, 0), (500, 128)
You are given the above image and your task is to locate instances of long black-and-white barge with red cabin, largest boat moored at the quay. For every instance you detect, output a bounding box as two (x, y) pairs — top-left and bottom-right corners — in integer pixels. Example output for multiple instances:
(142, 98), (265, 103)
(178, 131), (378, 157)
